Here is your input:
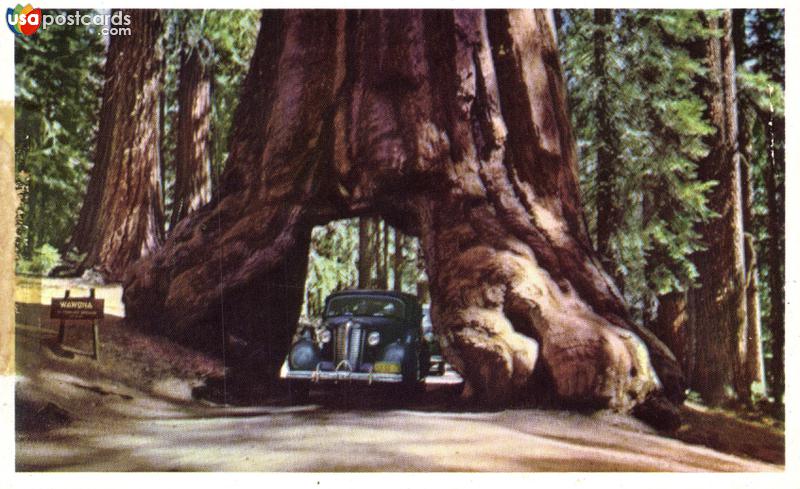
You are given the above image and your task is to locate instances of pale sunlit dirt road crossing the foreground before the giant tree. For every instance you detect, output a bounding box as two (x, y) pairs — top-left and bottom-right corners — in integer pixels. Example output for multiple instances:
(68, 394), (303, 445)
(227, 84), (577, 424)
(17, 372), (778, 471)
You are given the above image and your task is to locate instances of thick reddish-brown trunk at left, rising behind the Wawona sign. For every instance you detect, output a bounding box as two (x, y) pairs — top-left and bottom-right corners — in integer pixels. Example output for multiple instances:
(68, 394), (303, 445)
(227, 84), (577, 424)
(68, 10), (163, 280)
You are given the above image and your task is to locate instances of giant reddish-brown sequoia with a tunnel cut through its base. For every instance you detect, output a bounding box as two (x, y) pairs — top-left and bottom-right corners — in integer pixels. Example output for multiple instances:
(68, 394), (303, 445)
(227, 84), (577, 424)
(124, 10), (682, 409)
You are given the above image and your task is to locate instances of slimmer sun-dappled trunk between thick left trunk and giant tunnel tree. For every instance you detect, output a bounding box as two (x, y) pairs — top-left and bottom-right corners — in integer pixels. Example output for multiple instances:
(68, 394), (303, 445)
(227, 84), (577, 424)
(170, 45), (211, 229)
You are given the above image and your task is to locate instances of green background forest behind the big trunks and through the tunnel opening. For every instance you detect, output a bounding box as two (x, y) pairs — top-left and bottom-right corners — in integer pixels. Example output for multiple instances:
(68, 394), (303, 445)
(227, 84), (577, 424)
(15, 10), (785, 410)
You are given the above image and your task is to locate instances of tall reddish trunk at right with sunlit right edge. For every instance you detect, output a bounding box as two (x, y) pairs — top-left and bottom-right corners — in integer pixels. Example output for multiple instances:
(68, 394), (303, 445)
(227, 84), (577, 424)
(690, 11), (749, 405)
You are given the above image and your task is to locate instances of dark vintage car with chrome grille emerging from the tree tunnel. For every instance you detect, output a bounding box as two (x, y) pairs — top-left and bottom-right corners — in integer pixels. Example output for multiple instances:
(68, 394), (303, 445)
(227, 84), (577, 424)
(280, 290), (430, 400)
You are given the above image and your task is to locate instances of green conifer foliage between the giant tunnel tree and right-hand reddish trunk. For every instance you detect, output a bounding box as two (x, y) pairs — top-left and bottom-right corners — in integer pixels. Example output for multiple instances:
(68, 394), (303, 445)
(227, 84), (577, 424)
(559, 10), (713, 315)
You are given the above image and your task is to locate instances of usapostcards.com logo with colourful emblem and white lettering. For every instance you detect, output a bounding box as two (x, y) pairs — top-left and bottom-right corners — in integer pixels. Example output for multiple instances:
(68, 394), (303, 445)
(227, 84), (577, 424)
(6, 4), (131, 36)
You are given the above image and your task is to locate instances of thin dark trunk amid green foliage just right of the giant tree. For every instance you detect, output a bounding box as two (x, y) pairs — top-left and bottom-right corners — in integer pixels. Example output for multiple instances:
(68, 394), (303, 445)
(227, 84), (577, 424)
(592, 9), (624, 287)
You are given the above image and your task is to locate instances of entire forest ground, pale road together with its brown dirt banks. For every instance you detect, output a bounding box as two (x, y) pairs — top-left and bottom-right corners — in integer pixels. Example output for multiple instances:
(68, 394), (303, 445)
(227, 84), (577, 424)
(10, 278), (784, 472)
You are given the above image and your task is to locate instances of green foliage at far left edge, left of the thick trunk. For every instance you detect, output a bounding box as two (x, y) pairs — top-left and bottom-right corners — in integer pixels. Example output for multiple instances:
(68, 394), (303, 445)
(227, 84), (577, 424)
(14, 8), (105, 260)
